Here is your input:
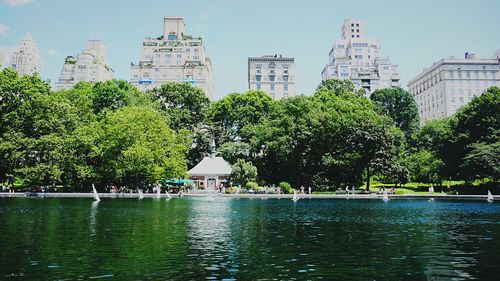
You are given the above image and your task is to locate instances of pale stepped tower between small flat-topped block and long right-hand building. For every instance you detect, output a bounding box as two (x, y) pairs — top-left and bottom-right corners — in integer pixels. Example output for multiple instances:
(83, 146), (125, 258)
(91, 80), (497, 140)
(321, 19), (400, 96)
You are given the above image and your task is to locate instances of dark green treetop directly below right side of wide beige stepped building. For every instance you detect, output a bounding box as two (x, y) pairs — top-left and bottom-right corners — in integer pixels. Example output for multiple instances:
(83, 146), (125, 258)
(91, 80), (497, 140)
(150, 82), (210, 131)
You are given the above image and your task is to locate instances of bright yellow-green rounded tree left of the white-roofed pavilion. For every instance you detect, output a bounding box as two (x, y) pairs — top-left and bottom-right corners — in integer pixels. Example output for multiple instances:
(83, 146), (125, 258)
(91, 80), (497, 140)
(90, 106), (190, 187)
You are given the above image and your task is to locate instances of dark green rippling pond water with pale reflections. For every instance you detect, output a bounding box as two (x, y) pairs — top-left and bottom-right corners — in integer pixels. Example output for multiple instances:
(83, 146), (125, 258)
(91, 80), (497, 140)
(0, 198), (500, 280)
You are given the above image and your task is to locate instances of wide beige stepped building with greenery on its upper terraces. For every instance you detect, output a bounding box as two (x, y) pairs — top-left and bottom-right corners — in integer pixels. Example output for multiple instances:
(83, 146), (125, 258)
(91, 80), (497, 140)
(130, 17), (214, 99)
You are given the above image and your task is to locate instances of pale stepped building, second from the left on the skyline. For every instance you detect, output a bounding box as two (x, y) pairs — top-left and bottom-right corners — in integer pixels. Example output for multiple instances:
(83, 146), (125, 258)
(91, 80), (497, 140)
(54, 40), (114, 90)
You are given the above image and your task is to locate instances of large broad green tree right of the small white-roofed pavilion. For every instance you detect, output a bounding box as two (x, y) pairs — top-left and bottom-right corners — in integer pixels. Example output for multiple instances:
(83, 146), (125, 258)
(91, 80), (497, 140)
(245, 88), (397, 189)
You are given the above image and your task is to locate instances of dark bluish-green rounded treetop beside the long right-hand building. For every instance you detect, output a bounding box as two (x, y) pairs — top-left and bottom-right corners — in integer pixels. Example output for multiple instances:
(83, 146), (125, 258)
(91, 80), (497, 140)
(370, 87), (419, 136)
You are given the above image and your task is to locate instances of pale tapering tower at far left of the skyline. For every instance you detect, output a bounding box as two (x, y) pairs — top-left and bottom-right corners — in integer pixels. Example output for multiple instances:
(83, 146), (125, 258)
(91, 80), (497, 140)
(10, 32), (42, 76)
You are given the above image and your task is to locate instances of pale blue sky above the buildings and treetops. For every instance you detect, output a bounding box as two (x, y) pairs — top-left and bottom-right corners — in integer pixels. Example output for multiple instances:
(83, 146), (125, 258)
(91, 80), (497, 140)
(0, 0), (500, 99)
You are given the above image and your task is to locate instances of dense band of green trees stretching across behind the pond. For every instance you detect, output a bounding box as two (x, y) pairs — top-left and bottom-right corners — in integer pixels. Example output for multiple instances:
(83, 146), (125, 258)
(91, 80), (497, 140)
(0, 69), (500, 189)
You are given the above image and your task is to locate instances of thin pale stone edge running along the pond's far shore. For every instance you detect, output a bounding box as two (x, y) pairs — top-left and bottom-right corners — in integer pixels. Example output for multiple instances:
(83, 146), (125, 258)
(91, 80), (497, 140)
(0, 192), (500, 201)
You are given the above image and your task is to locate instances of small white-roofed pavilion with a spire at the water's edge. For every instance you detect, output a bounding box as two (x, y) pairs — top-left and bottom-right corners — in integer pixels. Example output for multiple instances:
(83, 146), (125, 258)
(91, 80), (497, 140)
(188, 141), (232, 190)
